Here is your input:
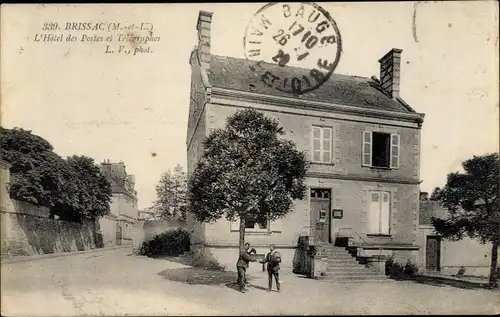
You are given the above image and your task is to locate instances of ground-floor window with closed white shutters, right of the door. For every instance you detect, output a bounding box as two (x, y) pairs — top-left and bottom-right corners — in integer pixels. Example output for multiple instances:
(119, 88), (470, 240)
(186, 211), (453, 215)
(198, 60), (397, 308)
(368, 191), (391, 234)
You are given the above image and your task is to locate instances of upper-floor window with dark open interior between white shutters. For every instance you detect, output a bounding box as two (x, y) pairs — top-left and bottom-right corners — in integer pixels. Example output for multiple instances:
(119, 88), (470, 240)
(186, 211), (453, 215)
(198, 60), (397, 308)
(362, 131), (399, 168)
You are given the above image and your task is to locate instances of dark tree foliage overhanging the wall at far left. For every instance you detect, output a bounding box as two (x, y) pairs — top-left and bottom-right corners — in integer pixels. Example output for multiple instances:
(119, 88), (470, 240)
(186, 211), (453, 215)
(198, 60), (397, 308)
(0, 128), (111, 220)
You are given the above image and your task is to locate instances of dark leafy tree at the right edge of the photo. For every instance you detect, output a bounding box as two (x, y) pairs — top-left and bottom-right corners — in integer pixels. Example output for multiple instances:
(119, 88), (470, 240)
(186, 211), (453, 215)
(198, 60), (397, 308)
(432, 153), (500, 287)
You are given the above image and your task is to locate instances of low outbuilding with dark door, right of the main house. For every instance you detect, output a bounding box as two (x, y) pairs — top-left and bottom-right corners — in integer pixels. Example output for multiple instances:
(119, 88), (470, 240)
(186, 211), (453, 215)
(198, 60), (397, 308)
(418, 200), (491, 276)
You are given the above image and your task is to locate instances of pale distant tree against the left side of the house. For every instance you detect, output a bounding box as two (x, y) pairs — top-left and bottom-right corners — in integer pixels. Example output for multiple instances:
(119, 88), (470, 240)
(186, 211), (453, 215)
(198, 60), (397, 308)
(154, 165), (187, 220)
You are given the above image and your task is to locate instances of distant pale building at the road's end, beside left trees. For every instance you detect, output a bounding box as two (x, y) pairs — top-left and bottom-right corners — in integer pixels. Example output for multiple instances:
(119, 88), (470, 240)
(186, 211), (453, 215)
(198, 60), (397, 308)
(100, 160), (139, 246)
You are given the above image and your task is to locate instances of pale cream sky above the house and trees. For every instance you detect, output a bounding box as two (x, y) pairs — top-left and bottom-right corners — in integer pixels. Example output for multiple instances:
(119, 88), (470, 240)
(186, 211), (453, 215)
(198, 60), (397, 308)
(1, 1), (499, 209)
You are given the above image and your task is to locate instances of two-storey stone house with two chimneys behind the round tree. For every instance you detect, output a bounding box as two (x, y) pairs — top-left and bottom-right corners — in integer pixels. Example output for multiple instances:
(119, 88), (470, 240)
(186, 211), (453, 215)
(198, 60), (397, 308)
(186, 11), (424, 267)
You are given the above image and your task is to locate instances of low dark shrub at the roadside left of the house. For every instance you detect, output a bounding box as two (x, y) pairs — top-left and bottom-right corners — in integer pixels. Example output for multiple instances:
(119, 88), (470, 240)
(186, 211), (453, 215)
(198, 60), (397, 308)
(139, 228), (190, 257)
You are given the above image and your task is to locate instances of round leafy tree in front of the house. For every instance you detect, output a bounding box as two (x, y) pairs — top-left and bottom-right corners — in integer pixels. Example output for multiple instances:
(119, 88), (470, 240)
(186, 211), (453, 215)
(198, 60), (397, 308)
(188, 109), (307, 250)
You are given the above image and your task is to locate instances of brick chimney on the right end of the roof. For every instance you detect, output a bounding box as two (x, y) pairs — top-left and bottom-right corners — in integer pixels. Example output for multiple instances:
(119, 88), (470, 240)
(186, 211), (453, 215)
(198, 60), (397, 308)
(378, 48), (403, 99)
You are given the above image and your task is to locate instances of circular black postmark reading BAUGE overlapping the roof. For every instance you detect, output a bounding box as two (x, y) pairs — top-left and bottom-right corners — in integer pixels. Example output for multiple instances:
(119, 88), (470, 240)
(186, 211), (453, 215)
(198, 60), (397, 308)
(243, 2), (342, 95)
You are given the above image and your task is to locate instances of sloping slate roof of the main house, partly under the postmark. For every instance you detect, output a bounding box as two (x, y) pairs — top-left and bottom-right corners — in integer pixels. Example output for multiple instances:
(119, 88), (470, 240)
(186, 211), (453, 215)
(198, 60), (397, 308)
(209, 55), (415, 113)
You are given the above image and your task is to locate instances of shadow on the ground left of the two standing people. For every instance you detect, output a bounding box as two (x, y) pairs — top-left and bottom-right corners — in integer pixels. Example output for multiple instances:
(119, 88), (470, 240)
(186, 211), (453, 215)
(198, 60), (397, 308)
(158, 267), (253, 289)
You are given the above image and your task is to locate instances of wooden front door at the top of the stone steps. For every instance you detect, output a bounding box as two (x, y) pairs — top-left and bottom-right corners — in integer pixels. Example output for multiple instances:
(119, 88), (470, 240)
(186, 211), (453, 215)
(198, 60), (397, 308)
(311, 188), (332, 243)
